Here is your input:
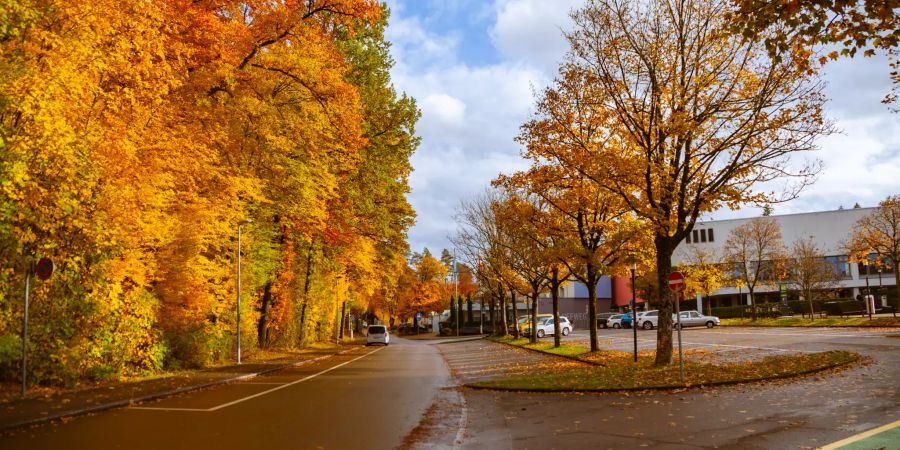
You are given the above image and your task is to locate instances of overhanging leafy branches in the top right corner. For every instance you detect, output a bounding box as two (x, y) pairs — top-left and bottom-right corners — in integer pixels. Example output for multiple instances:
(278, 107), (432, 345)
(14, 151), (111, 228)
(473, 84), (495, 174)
(728, 0), (900, 103)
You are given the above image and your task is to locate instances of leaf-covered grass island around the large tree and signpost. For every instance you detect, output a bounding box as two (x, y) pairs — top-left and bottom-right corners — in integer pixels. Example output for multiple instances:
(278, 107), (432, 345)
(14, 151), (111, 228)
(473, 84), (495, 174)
(470, 351), (860, 391)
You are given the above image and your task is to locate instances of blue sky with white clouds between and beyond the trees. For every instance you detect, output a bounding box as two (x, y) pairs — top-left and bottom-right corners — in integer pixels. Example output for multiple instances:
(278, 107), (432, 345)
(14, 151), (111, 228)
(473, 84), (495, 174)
(387, 0), (900, 253)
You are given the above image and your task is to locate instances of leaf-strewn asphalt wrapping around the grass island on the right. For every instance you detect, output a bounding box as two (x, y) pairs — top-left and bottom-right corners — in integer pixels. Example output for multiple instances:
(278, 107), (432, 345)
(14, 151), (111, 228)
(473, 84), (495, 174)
(463, 328), (900, 449)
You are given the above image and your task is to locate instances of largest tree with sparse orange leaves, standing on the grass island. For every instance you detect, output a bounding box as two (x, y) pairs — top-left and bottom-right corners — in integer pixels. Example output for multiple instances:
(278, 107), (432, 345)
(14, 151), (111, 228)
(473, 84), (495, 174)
(552, 0), (830, 365)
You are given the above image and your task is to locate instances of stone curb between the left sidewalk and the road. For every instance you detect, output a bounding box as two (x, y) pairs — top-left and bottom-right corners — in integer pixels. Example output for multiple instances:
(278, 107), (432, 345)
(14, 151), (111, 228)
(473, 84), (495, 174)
(0, 348), (353, 431)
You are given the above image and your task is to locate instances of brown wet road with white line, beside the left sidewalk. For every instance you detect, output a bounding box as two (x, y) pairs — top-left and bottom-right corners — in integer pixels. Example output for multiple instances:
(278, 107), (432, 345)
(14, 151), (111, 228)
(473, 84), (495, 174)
(0, 339), (456, 450)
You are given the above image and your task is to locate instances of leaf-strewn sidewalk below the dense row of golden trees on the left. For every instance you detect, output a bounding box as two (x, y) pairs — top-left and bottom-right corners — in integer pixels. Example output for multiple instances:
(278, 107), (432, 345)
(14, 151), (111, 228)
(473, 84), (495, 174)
(0, 345), (357, 430)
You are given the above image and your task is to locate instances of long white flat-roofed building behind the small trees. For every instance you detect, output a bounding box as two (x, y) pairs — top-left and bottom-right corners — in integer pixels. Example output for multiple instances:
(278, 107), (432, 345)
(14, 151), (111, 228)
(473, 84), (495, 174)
(673, 208), (895, 306)
